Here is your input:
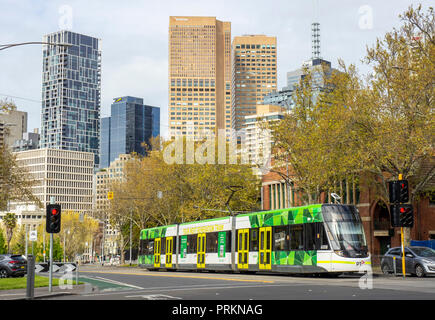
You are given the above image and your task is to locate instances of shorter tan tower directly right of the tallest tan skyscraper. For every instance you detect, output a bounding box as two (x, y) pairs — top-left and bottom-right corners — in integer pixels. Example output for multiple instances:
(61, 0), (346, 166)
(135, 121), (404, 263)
(232, 35), (277, 130)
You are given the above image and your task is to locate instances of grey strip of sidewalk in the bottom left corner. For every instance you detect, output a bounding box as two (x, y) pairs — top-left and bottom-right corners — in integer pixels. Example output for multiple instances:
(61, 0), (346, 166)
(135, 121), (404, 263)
(0, 284), (85, 300)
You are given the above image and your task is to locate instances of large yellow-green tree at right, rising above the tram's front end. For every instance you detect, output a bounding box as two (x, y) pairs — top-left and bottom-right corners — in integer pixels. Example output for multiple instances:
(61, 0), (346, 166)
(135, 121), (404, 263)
(273, 6), (435, 242)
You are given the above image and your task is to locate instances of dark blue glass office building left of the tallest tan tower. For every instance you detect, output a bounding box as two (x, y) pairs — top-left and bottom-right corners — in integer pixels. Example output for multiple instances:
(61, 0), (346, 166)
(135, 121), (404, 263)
(100, 96), (160, 168)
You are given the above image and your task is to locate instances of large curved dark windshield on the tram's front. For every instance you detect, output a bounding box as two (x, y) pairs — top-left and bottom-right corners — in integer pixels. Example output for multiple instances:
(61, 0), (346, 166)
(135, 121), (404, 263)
(322, 205), (368, 258)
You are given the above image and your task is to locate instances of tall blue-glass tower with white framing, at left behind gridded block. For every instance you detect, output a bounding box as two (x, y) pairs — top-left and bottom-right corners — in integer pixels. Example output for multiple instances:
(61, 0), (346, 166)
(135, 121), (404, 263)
(41, 31), (101, 167)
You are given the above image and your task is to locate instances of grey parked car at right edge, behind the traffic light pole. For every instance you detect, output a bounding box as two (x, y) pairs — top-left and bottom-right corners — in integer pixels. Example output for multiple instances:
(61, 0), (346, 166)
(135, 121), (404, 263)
(381, 247), (435, 277)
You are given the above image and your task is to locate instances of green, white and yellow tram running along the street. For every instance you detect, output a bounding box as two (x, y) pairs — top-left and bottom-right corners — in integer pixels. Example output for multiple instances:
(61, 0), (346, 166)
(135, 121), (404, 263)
(139, 204), (371, 273)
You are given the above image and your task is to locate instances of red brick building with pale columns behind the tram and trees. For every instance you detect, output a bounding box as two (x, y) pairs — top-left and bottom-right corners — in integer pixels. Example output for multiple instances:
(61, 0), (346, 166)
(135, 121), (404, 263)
(261, 162), (435, 265)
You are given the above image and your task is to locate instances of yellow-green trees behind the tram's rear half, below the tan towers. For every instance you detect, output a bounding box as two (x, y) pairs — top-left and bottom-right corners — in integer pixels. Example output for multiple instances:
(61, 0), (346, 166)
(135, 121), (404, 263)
(109, 141), (259, 263)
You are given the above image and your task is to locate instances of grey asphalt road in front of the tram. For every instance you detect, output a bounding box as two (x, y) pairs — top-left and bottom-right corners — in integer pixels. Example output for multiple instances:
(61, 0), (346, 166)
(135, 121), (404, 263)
(43, 266), (435, 301)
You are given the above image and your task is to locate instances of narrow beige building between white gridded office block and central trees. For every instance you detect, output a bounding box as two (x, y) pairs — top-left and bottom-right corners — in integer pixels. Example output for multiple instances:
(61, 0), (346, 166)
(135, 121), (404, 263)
(95, 154), (131, 256)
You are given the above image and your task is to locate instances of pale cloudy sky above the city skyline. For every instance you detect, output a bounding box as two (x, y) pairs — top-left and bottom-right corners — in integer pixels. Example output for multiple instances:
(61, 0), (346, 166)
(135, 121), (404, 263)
(0, 0), (433, 136)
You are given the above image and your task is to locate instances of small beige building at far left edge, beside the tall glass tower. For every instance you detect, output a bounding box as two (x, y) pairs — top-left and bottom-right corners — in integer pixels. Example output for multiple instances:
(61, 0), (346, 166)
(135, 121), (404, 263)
(0, 110), (27, 148)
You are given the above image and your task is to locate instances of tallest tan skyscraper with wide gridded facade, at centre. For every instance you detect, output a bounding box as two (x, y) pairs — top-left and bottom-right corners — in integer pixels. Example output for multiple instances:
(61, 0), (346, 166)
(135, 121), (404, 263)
(168, 17), (232, 137)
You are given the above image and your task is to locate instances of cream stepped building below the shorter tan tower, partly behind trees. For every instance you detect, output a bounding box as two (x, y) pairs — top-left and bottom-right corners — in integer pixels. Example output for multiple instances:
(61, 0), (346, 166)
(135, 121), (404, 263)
(244, 105), (284, 176)
